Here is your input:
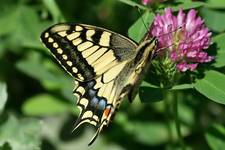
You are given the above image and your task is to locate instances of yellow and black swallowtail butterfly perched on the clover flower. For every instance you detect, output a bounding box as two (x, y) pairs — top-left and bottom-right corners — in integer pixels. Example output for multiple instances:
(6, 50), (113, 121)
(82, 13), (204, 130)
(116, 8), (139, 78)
(41, 23), (157, 145)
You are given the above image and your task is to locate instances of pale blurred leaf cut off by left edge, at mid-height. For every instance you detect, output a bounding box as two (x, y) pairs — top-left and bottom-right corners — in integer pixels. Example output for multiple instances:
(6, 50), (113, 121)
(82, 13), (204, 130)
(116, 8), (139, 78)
(0, 82), (8, 114)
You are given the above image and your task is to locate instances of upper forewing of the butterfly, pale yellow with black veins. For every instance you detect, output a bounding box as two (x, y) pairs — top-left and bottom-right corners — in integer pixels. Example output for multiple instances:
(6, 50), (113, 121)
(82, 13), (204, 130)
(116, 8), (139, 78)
(41, 23), (137, 81)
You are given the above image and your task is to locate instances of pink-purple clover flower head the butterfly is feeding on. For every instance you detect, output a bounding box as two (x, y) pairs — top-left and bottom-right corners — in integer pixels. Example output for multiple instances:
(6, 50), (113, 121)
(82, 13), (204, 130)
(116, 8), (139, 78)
(150, 8), (214, 72)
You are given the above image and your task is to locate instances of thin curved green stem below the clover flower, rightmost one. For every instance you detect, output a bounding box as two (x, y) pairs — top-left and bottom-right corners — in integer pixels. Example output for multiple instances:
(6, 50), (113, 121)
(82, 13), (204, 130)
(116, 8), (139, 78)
(173, 92), (186, 150)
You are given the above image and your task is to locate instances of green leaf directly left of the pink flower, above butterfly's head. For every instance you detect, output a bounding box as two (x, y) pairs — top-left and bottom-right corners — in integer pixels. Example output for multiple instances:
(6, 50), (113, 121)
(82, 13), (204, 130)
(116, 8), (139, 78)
(128, 11), (155, 42)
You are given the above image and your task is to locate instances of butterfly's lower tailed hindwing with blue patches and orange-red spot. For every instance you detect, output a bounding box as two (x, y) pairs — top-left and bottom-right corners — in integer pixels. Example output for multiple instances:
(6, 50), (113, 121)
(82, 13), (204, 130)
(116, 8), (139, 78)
(71, 57), (134, 144)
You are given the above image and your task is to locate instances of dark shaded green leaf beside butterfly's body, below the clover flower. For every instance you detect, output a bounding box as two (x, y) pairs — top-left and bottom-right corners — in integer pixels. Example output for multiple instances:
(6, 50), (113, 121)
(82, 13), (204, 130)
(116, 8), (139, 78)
(139, 87), (163, 103)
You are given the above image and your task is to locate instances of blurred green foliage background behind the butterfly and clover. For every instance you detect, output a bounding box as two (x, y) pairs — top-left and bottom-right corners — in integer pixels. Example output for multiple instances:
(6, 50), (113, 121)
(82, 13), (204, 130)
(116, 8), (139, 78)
(0, 0), (225, 150)
